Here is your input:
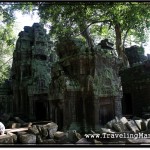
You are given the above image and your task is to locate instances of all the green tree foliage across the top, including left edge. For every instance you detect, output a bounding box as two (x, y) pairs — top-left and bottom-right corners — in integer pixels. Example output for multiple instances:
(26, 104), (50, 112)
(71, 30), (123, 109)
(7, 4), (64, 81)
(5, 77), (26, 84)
(0, 2), (150, 79)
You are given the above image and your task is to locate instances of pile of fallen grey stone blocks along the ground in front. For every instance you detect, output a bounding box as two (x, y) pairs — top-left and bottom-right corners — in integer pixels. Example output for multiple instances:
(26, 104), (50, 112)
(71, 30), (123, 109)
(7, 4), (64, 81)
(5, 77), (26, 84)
(0, 117), (150, 145)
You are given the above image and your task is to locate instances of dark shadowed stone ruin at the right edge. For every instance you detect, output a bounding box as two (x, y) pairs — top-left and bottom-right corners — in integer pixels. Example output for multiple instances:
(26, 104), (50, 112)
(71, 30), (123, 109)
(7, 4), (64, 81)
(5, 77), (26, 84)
(120, 46), (150, 118)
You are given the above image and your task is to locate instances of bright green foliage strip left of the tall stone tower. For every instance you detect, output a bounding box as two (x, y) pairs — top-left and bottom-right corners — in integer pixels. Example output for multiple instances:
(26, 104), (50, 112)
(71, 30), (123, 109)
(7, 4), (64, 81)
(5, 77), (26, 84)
(0, 3), (15, 83)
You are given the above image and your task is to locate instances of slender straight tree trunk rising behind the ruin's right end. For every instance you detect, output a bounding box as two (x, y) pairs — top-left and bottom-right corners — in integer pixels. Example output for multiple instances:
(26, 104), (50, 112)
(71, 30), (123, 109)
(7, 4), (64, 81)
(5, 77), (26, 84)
(115, 23), (128, 67)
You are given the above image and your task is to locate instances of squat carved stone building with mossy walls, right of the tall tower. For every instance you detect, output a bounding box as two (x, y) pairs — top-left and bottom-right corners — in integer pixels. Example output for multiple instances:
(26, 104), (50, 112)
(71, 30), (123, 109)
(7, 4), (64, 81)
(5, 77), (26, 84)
(50, 38), (122, 131)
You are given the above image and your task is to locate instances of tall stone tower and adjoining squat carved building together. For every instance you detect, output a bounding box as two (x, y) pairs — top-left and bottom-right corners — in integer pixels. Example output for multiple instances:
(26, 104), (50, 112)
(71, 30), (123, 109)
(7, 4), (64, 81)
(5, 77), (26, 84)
(0, 23), (122, 131)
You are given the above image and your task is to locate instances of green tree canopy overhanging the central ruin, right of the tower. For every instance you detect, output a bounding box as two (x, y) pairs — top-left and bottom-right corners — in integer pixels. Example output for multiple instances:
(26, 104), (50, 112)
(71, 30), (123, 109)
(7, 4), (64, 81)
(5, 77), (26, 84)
(36, 2), (150, 50)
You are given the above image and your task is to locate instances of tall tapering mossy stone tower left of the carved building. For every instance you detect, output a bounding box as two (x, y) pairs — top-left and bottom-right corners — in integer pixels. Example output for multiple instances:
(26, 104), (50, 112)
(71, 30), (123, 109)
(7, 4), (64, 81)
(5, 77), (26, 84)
(12, 23), (50, 120)
